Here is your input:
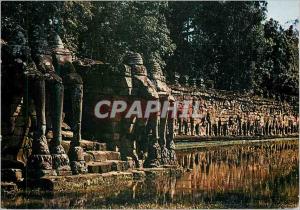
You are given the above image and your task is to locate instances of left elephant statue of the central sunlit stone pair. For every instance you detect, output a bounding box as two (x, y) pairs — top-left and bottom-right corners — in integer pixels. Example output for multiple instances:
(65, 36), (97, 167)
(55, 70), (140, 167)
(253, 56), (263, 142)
(124, 52), (161, 167)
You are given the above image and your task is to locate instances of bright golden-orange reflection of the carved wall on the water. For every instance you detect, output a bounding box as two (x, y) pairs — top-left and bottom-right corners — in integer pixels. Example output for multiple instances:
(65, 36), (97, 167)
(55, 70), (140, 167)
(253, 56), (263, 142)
(176, 141), (298, 191)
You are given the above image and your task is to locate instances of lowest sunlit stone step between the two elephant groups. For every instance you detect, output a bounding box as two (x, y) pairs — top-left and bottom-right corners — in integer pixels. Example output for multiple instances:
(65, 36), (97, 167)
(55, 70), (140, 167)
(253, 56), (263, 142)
(87, 160), (130, 173)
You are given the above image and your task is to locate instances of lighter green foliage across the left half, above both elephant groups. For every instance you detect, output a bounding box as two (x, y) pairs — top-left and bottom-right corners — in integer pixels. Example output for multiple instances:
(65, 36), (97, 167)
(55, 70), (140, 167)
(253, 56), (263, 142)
(1, 1), (175, 66)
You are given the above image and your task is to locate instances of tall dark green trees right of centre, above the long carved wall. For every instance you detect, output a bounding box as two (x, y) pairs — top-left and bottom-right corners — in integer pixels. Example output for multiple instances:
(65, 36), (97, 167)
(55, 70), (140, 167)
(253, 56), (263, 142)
(169, 2), (266, 90)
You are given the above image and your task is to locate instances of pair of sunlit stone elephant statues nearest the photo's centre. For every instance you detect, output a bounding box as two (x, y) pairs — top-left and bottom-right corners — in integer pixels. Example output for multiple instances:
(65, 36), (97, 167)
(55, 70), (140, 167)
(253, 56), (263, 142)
(121, 52), (176, 167)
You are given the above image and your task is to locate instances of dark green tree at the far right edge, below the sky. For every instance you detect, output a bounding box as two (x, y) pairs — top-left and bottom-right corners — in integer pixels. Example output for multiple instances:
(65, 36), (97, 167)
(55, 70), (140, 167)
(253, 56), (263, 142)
(264, 19), (299, 96)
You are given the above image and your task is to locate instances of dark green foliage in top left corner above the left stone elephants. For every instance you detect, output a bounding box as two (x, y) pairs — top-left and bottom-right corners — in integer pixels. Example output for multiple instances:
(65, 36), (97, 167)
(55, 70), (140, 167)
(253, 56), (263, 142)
(1, 1), (92, 52)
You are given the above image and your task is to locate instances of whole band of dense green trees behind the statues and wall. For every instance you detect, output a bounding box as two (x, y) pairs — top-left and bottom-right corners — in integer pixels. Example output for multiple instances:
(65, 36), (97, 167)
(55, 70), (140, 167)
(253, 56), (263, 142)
(1, 1), (299, 101)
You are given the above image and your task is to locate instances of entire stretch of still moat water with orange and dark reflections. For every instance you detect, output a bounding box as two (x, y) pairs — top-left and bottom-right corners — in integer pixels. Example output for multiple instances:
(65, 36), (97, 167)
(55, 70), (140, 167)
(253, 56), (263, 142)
(1, 140), (299, 208)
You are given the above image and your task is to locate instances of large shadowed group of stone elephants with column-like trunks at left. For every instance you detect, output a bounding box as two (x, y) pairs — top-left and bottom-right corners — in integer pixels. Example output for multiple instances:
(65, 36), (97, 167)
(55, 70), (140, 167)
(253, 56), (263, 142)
(2, 24), (86, 176)
